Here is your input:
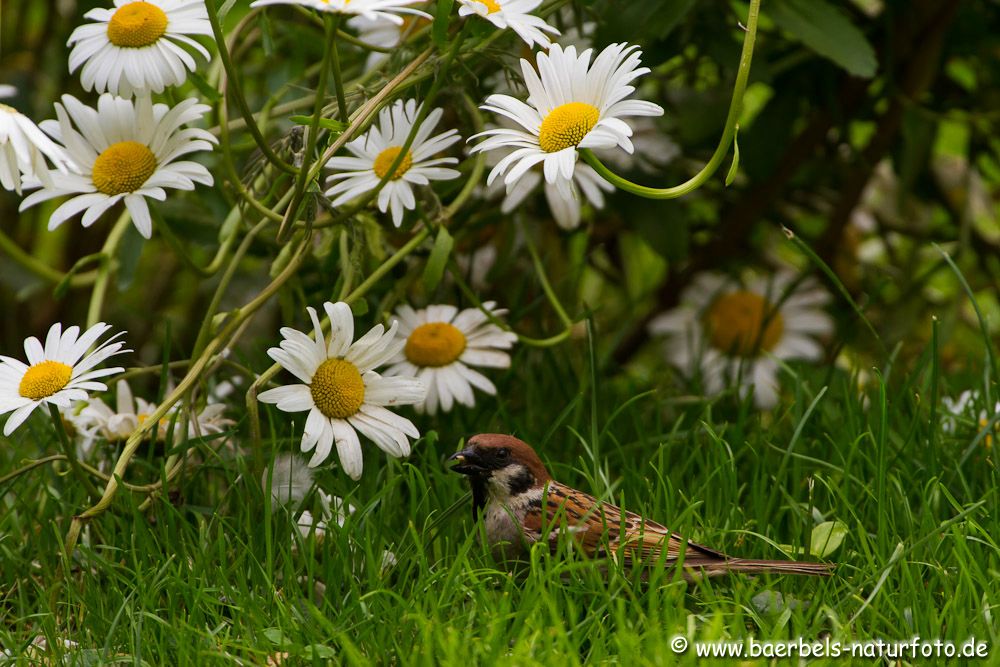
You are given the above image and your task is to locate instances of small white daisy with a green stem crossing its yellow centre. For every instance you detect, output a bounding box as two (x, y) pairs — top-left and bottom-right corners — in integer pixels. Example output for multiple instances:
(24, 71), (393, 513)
(326, 100), (461, 227)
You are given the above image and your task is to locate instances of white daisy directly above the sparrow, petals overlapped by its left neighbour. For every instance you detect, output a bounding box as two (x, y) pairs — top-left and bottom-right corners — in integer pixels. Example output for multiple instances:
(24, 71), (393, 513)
(385, 301), (517, 415)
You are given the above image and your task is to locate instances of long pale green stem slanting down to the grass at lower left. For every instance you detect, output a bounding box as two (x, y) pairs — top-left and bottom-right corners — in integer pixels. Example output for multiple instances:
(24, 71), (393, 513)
(65, 234), (312, 554)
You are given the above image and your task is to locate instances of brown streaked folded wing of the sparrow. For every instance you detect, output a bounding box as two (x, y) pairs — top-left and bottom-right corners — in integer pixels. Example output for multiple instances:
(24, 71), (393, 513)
(523, 481), (727, 565)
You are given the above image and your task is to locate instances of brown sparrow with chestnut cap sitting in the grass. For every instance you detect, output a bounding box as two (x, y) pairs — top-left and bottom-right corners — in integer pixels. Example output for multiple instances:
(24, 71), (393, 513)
(448, 433), (834, 580)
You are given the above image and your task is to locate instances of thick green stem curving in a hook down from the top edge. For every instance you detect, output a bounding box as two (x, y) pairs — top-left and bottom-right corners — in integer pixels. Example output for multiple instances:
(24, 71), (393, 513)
(580, 0), (760, 199)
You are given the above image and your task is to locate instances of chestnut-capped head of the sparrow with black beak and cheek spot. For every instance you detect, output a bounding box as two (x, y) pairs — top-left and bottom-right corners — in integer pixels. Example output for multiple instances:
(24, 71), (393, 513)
(448, 433), (552, 496)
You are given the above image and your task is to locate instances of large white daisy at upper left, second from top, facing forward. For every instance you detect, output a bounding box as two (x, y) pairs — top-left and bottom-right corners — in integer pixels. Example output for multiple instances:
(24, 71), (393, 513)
(20, 94), (216, 239)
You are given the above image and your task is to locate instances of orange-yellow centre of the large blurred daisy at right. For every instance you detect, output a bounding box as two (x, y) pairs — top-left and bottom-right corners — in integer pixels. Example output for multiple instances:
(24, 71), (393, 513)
(705, 290), (785, 357)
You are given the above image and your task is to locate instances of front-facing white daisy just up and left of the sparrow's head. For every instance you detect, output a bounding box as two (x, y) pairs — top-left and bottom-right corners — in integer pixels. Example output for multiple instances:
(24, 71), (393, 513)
(258, 302), (427, 479)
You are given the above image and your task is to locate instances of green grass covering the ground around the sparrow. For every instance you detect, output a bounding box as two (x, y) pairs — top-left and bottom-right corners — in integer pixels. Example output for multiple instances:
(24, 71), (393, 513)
(0, 332), (1000, 665)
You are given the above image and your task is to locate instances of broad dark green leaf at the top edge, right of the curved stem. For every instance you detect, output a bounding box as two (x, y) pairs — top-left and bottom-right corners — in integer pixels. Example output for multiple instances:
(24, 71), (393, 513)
(767, 0), (878, 78)
